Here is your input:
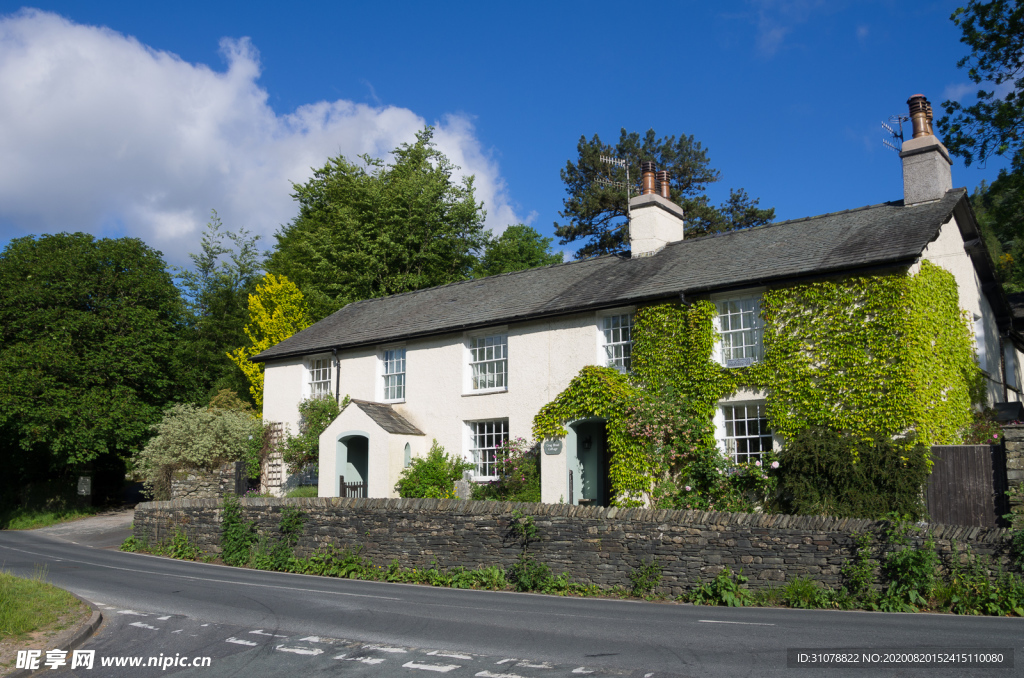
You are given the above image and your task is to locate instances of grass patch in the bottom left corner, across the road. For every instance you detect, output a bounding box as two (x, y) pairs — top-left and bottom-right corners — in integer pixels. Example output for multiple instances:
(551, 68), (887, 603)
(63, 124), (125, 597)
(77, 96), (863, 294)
(0, 570), (85, 640)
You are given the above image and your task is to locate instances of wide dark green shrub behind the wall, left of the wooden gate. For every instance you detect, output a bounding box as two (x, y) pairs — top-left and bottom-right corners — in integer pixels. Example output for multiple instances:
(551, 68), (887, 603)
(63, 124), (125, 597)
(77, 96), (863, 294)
(778, 429), (929, 520)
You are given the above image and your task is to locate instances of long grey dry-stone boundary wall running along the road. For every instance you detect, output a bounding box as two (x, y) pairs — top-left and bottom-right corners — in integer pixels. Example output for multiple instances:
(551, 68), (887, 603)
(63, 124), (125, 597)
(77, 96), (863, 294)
(134, 498), (1010, 595)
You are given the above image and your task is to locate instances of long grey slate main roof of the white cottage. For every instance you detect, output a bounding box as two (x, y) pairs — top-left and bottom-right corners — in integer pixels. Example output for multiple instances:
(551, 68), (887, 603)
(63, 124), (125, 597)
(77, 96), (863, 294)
(252, 188), (966, 362)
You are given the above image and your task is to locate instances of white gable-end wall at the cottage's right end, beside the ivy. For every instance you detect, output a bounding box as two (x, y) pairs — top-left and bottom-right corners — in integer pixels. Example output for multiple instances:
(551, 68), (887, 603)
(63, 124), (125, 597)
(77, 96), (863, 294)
(911, 216), (1002, 405)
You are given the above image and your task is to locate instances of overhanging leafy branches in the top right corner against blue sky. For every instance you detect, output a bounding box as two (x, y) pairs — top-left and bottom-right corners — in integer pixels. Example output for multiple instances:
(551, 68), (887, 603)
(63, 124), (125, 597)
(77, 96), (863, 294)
(937, 0), (1024, 172)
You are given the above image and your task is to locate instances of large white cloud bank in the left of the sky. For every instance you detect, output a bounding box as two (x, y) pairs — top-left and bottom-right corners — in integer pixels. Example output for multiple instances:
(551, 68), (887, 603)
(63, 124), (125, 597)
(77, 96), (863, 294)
(0, 10), (521, 263)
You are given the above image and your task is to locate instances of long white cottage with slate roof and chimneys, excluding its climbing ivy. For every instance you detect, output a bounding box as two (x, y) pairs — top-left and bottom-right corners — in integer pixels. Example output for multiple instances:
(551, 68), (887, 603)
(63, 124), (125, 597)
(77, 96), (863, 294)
(254, 95), (1024, 504)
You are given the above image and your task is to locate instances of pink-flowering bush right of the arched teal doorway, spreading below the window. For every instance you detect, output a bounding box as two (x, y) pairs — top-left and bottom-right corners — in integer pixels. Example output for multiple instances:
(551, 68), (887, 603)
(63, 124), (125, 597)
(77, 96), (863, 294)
(626, 390), (778, 511)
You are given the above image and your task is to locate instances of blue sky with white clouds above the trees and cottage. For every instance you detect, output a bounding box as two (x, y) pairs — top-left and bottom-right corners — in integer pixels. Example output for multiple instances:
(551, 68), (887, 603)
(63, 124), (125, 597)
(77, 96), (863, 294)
(0, 0), (1006, 264)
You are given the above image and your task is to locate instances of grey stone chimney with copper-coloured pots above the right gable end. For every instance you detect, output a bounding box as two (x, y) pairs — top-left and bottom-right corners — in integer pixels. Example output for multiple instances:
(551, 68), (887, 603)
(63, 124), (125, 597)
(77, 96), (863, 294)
(899, 94), (953, 205)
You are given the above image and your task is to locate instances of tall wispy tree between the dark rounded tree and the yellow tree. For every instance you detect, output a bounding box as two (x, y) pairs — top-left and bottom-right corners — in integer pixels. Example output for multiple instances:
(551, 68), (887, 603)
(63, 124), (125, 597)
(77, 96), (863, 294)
(178, 211), (263, 399)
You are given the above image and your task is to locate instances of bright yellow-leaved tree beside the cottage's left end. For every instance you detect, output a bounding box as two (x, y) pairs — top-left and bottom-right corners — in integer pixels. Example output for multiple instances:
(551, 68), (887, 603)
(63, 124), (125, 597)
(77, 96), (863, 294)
(227, 273), (311, 409)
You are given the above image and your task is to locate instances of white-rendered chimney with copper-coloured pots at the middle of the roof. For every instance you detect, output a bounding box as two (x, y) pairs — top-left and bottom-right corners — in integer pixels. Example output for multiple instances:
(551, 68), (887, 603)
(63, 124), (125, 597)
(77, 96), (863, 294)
(630, 162), (683, 257)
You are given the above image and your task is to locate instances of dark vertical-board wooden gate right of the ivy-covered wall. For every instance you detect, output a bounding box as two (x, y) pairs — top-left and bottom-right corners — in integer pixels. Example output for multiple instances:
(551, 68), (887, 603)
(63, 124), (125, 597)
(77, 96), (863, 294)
(928, 444), (1009, 527)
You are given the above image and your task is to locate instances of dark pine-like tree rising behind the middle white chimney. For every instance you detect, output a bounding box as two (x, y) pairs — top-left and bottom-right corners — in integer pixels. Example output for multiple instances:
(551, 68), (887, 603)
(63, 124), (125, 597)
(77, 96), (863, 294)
(555, 129), (775, 259)
